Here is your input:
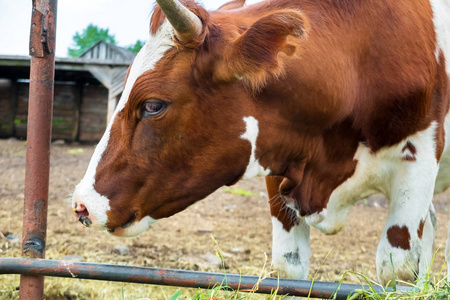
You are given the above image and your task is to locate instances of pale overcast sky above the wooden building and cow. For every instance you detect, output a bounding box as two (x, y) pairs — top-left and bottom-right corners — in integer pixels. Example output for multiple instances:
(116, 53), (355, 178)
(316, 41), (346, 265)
(0, 0), (260, 57)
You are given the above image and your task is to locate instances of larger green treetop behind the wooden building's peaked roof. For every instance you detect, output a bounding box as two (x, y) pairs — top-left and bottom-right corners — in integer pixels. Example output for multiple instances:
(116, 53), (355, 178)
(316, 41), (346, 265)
(69, 24), (116, 57)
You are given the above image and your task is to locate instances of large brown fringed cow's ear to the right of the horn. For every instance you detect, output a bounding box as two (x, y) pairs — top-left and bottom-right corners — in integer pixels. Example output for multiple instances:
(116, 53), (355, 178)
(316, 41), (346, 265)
(216, 9), (309, 89)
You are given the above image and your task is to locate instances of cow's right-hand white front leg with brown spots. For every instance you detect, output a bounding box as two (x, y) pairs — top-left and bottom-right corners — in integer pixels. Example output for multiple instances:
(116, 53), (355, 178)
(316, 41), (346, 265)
(376, 145), (438, 284)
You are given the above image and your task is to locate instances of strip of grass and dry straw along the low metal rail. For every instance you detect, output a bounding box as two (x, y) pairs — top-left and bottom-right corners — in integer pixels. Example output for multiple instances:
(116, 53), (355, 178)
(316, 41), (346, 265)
(0, 240), (450, 300)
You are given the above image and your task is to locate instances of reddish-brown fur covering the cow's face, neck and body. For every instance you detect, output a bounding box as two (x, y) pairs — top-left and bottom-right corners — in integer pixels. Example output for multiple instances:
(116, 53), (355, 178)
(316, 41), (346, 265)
(90, 0), (450, 230)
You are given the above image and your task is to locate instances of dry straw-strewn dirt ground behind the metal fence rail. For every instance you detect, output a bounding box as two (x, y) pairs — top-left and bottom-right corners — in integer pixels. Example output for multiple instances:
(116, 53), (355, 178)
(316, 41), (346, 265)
(0, 139), (450, 299)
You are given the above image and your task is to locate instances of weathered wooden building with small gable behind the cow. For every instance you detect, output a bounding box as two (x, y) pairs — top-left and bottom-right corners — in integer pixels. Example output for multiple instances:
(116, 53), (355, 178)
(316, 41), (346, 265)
(0, 41), (134, 142)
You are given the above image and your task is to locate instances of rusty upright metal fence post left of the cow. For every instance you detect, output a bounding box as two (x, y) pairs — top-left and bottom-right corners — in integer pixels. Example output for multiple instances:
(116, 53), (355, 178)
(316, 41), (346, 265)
(19, 0), (57, 300)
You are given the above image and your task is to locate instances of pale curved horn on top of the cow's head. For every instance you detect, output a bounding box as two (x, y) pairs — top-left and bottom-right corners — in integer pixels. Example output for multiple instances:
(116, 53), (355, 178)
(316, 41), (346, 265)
(156, 0), (203, 42)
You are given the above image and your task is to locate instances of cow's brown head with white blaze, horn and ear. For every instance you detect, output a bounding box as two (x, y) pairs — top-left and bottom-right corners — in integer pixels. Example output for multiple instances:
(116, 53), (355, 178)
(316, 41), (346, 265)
(72, 0), (305, 236)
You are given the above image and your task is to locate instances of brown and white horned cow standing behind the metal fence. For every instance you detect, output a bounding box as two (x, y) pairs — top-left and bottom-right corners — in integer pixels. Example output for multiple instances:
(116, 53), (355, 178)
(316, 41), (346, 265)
(72, 0), (450, 283)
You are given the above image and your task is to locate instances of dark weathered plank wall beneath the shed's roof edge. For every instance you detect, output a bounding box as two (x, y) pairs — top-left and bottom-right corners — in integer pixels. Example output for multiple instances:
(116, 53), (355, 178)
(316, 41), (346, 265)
(0, 79), (108, 142)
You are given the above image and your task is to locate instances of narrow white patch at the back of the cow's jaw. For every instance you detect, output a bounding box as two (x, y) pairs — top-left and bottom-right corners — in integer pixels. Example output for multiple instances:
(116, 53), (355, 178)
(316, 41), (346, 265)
(241, 117), (270, 179)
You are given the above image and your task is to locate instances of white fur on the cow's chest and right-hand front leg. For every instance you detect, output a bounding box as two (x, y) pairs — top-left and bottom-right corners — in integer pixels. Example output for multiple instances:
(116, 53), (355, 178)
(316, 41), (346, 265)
(311, 122), (438, 283)
